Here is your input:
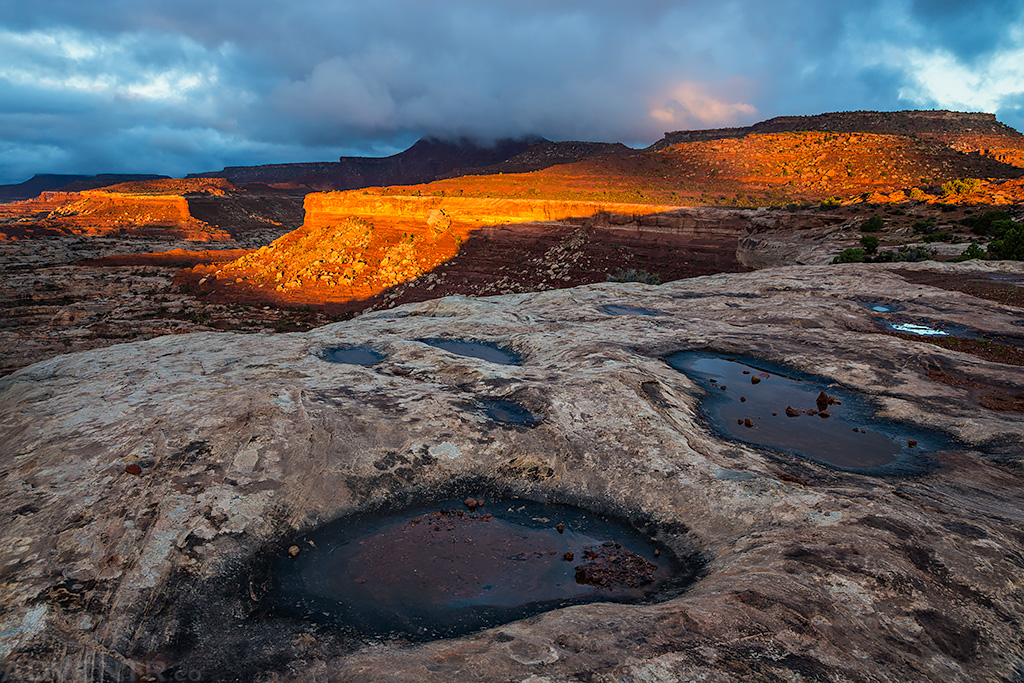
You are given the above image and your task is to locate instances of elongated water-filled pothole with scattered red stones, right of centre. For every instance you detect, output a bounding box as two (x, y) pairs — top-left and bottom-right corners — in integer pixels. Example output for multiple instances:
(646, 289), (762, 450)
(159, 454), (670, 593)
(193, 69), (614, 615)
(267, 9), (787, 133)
(667, 351), (944, 473)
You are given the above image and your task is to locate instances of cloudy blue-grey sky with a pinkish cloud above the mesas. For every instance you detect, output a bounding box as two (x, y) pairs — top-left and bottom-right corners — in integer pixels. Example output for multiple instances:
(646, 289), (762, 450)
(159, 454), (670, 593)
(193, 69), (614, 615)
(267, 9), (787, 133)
(0, 0), (1024, 183)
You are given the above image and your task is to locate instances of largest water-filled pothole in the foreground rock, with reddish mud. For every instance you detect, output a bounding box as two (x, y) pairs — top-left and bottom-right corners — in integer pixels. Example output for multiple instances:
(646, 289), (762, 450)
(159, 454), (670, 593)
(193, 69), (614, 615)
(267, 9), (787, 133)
(264, 499), (695, 640)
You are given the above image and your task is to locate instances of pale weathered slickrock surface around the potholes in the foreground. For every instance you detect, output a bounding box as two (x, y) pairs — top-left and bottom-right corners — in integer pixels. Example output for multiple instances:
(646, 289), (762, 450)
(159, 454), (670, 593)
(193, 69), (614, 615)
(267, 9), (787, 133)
(0, 262), (1024, 683)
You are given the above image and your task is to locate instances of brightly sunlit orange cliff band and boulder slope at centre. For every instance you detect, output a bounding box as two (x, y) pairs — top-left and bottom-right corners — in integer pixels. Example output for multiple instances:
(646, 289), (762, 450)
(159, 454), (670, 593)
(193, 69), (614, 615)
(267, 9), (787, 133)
(184, 190), (692, 305)
